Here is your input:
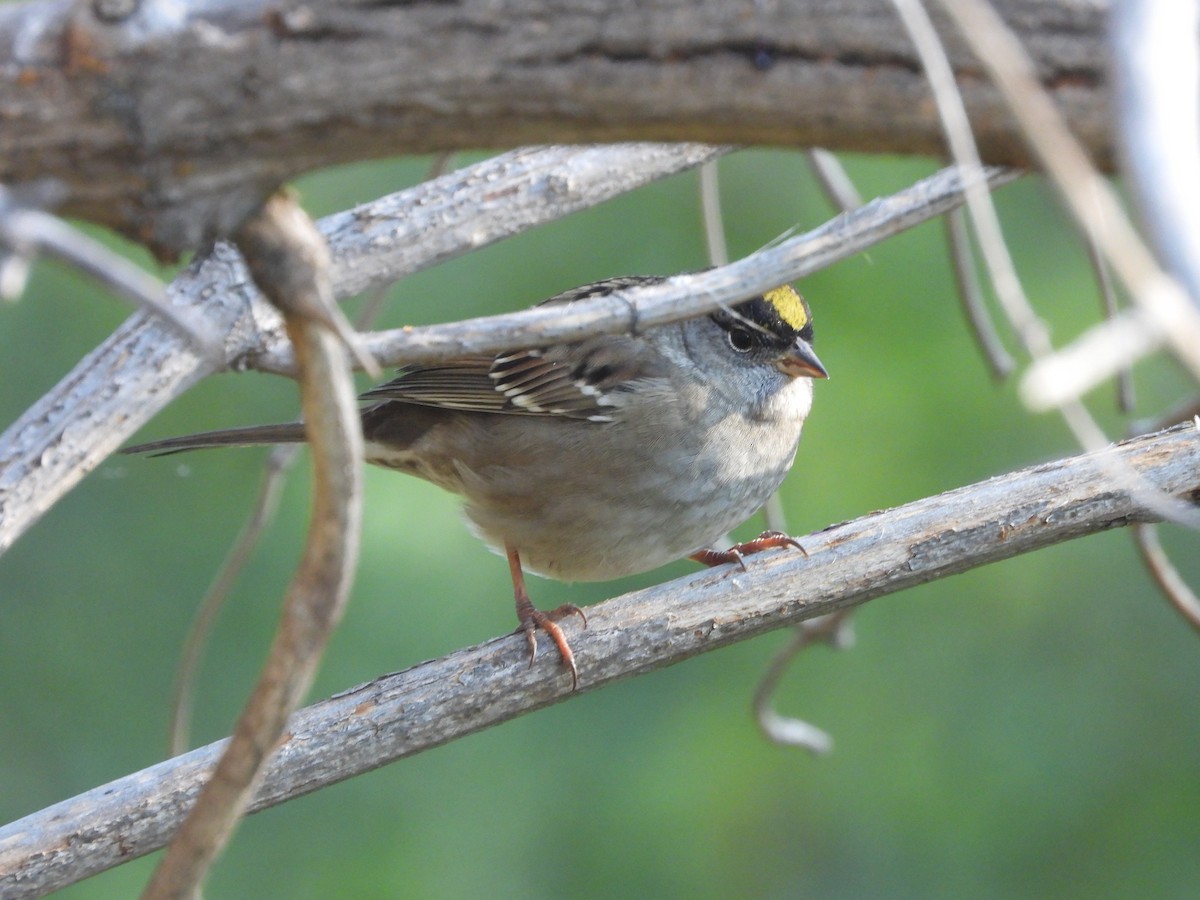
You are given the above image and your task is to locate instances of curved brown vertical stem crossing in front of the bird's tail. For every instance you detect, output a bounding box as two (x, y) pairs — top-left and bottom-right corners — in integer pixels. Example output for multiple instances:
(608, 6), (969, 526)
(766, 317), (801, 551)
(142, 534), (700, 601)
(143, 193), (362, 900)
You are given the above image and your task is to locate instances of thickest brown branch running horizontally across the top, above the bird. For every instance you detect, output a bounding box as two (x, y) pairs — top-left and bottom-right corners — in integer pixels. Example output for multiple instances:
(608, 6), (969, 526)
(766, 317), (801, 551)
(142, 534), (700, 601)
(0, 0), (1112, 251)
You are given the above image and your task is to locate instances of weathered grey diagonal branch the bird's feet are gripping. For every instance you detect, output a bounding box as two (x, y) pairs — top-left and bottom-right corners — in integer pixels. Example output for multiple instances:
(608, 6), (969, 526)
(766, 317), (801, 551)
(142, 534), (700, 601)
(0, 424), (1200, 896)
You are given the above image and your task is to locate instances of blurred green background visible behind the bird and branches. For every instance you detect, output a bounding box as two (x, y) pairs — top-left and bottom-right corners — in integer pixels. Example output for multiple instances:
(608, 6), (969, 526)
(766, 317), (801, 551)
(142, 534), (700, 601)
(0, 151), (1200, 898)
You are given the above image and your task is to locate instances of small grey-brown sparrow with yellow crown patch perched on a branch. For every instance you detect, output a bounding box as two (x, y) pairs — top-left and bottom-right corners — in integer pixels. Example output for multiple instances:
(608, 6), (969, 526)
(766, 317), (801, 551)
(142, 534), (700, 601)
(124, 275), (828, 690)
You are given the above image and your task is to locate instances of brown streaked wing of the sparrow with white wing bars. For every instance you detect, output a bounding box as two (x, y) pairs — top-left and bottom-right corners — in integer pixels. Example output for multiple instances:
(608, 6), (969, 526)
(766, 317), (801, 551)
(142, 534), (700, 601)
(362, 276), (661, 421)
